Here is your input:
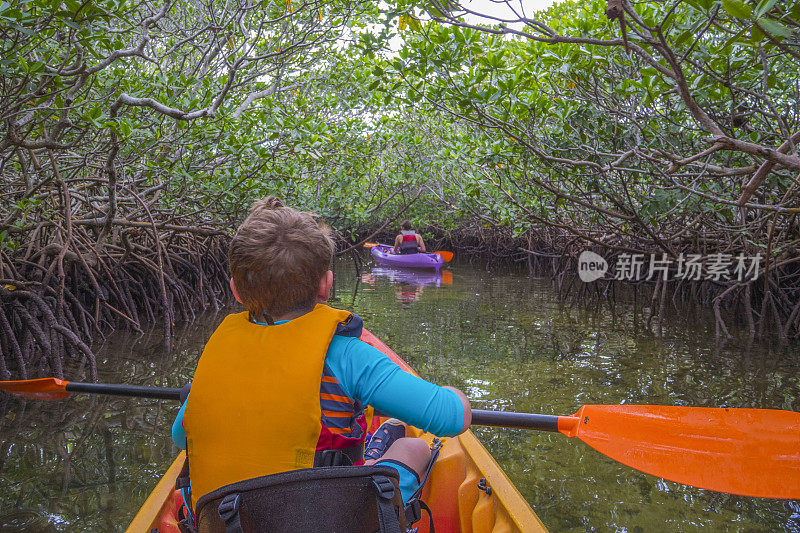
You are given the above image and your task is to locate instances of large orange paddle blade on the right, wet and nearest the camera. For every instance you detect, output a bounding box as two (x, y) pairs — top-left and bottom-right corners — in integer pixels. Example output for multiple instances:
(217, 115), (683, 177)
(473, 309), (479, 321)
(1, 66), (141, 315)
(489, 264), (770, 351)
(558, 405), (800, 499)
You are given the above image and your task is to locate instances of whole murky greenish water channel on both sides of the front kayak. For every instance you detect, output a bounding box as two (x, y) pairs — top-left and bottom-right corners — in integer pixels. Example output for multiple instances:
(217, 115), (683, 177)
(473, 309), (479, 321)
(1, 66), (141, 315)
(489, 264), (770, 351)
(0, 261), (800, 532)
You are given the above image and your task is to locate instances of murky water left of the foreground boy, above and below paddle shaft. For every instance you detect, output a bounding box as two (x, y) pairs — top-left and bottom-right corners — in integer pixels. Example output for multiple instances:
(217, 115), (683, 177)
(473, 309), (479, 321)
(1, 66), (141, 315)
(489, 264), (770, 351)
(0, 313), (225, 532)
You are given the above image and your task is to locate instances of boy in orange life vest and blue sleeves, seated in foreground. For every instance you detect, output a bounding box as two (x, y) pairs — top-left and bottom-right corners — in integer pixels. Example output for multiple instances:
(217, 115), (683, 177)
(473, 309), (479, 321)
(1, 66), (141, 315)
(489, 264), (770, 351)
(172, 197), (471, 516)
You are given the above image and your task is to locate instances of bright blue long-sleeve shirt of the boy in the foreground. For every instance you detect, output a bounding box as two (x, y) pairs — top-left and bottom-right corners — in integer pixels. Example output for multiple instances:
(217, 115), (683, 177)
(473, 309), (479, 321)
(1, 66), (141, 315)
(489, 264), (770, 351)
(172, 328), (464, 449)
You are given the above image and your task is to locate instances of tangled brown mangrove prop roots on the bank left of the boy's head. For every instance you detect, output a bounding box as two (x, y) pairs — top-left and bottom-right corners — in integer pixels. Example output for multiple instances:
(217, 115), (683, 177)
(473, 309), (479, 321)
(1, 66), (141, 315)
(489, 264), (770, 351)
(0, 226), (228, 380)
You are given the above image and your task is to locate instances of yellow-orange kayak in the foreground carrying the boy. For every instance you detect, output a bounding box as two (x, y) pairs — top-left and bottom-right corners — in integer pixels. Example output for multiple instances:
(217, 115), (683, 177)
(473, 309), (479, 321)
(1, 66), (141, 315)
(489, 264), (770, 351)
(127, 329), (547, 533)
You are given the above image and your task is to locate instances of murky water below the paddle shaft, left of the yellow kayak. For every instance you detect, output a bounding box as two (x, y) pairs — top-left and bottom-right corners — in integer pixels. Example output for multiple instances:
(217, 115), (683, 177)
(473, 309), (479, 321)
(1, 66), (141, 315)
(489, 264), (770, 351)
(0, 395), (177, 531)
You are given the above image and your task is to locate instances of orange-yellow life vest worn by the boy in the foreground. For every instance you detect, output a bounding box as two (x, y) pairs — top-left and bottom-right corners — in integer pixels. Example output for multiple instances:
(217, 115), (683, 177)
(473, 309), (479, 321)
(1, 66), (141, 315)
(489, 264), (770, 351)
(183, 305), (351, 505)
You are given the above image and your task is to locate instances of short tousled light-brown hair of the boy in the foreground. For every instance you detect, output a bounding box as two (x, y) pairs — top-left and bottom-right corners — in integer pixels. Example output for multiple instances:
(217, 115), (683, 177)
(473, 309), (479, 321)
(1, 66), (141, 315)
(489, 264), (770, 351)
(228, 196), (334, 322)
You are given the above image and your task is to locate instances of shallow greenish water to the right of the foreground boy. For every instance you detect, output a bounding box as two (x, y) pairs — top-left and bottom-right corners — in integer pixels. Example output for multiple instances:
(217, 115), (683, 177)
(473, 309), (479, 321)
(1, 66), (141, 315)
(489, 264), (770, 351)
(342, 264), (800, 532)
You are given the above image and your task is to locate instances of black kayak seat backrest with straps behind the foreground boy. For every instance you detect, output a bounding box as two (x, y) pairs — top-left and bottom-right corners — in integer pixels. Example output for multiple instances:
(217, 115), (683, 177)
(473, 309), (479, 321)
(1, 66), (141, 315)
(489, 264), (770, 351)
(181, 465), (406, 533)
